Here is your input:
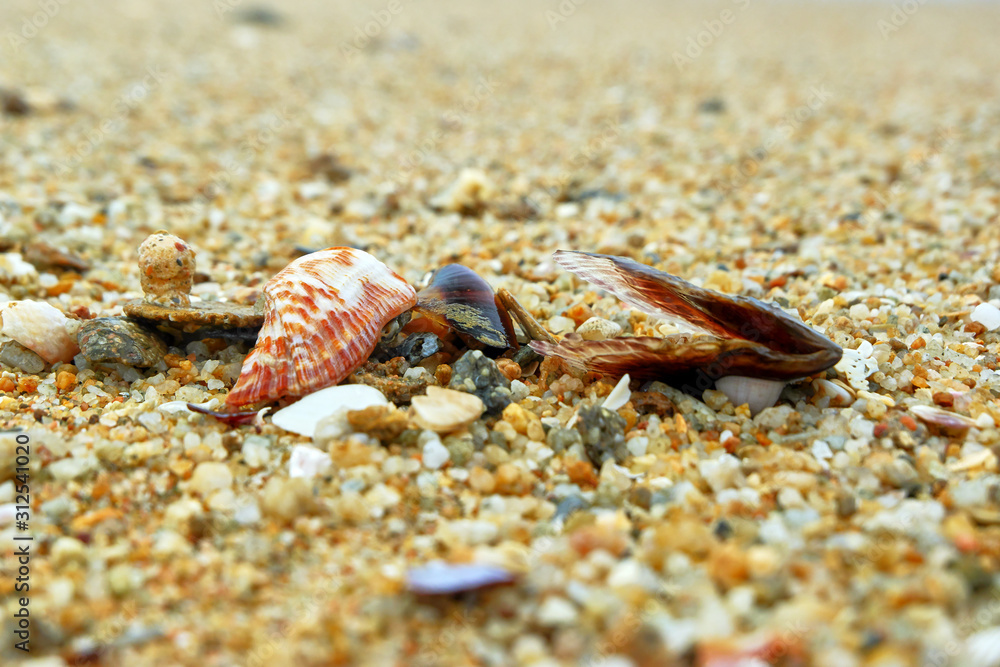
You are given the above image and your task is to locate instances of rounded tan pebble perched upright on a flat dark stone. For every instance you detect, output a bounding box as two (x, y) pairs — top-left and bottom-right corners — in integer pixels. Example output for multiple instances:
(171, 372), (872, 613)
(139, 229), (194, 306)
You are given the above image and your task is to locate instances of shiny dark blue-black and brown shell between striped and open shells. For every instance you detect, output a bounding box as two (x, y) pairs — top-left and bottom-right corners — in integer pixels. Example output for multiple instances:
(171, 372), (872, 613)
(414, 264), (517, 351)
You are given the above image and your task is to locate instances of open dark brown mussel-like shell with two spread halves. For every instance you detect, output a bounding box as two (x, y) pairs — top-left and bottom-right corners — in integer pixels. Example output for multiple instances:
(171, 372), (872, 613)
(531, 250), (843, 380)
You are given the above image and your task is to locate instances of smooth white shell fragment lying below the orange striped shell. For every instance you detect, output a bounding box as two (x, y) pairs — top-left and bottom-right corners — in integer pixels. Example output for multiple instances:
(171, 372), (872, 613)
(271, 384), (389, 438)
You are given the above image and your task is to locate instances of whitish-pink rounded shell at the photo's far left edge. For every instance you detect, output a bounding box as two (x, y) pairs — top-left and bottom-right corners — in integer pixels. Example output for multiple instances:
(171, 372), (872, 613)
(0, 301), (80, 364)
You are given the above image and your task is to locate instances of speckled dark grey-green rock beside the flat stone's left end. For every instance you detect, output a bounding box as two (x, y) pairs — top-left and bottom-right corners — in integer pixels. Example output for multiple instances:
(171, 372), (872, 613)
(78, 317), (167, 368)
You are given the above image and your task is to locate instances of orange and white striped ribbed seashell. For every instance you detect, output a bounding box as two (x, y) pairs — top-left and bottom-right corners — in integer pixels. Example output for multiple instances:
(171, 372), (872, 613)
(226, 248), (417, 406)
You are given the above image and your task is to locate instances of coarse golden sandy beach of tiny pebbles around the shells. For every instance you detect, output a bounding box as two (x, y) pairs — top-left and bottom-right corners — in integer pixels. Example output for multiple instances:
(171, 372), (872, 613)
(0, 0), (1000, 667)
